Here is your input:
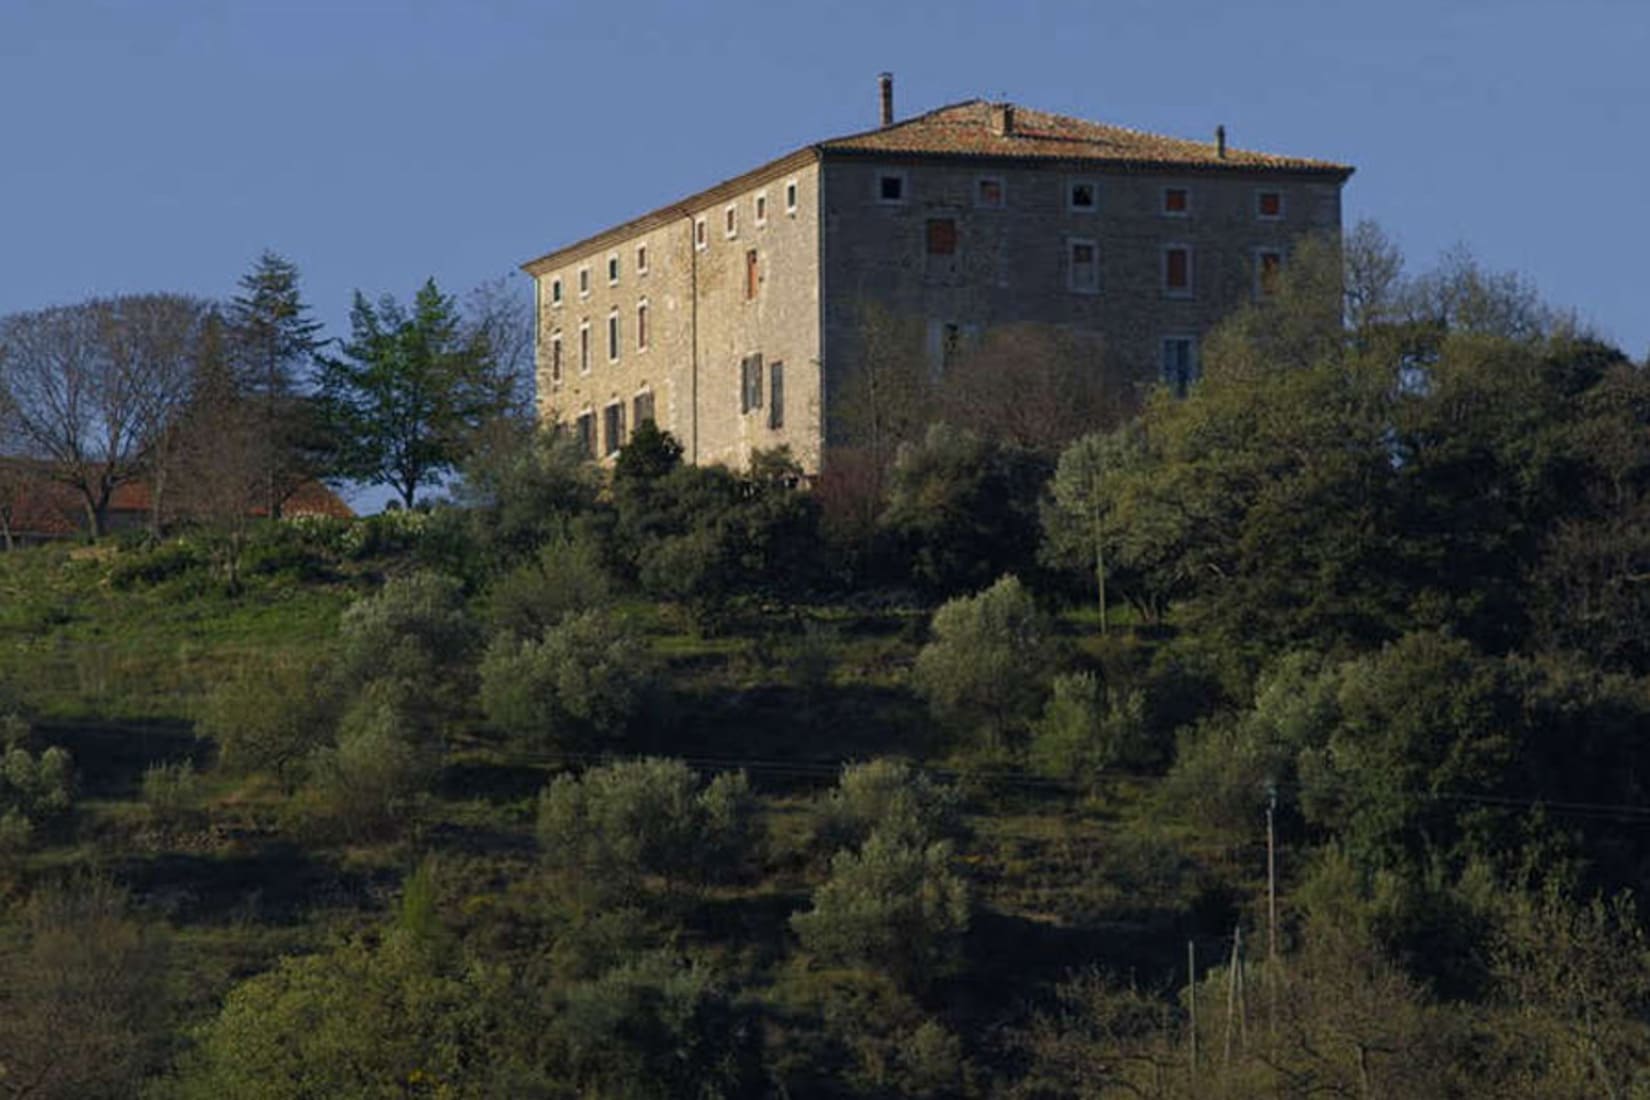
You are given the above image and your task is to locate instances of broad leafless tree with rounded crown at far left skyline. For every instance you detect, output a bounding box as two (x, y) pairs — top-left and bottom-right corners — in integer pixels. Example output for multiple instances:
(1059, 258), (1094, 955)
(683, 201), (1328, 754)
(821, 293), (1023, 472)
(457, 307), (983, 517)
(0, 295), (206, 536)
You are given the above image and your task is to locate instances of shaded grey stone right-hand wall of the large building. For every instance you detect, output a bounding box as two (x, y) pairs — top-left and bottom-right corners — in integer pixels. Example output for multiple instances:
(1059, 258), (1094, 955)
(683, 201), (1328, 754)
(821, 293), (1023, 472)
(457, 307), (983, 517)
(823, 157), (1340, 439)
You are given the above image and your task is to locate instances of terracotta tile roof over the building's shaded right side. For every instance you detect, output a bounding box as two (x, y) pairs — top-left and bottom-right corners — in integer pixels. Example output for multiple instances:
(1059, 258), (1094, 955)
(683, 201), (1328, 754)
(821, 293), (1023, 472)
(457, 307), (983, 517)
(820, 99), (1351, 175)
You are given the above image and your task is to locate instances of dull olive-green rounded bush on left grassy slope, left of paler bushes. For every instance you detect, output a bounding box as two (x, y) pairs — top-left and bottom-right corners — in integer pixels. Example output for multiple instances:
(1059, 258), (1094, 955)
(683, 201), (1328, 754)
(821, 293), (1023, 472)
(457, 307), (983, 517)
(195, 658), (340, 790)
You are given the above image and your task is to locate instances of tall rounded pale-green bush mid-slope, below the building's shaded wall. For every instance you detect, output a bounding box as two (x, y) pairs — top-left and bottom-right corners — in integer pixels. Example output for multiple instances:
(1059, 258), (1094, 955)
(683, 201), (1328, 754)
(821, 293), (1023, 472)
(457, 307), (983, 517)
(911, 577), (1056, 747)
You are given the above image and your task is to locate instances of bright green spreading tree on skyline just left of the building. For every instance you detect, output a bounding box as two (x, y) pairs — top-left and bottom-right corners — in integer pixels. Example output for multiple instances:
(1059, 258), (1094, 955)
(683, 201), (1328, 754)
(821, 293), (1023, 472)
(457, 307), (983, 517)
(317, 279), (510, 508)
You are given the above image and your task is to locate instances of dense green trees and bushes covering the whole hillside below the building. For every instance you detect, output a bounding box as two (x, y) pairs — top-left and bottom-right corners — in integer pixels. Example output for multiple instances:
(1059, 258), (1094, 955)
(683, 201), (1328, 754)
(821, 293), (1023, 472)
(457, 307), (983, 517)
(0, 229), (1650, 1098)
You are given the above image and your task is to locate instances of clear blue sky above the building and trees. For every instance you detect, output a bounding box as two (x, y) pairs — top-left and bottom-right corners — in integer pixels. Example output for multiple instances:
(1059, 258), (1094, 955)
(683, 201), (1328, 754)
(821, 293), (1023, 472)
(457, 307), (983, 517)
(0, 0), (1650, 504)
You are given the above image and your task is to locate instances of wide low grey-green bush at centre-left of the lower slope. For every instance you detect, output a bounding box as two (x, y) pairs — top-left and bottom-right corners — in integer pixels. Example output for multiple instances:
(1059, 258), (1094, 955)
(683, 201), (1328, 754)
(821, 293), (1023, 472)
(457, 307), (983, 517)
(538, 759), (761, 884)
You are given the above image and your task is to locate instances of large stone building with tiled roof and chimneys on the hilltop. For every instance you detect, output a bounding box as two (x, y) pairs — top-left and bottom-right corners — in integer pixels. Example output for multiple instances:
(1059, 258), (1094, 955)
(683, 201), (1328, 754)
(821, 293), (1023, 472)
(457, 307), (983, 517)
(525, 74), (1351, 472)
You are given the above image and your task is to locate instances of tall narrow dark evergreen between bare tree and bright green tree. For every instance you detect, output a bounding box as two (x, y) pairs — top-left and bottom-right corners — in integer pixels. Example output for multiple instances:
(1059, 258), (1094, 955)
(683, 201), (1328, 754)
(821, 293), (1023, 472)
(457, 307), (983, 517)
(229, 249), (322, 518)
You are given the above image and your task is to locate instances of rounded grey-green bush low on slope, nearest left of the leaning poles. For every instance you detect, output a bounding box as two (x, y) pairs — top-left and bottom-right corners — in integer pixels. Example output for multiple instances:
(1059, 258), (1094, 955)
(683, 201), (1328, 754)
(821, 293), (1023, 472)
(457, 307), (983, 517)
(790, 833), (969, 990)
